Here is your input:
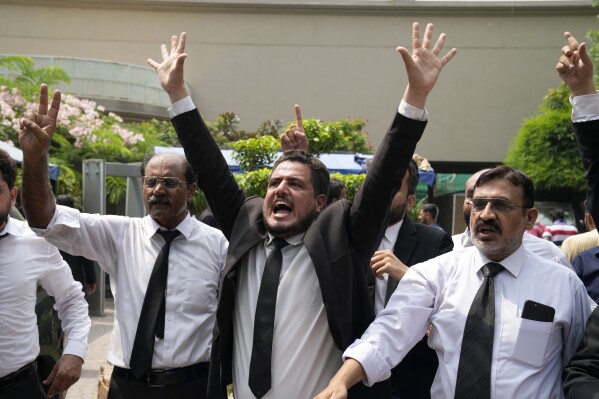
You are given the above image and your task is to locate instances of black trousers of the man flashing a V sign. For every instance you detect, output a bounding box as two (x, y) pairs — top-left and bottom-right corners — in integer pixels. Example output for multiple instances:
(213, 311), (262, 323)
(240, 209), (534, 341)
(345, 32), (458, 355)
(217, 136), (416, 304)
(108, 374), (208, 399)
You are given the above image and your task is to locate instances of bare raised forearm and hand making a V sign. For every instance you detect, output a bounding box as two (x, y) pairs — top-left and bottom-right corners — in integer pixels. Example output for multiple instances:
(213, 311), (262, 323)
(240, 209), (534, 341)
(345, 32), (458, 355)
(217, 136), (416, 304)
(19, 84), (61, 228)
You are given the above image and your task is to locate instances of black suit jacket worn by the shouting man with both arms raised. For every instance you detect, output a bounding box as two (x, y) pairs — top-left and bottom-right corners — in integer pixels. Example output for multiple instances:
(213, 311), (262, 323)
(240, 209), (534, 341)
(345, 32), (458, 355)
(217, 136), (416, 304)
(172, 110), (426, 398)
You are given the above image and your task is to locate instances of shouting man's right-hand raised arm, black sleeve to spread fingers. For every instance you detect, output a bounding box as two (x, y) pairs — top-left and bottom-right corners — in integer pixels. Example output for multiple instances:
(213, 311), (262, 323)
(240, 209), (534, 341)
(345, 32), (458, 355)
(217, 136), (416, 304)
(351, 22), (457, 258)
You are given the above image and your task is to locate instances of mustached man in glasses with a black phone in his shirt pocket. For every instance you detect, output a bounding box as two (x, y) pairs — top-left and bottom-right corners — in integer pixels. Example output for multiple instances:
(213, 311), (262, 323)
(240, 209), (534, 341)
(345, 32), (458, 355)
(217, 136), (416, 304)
(317, 166), (590, 399)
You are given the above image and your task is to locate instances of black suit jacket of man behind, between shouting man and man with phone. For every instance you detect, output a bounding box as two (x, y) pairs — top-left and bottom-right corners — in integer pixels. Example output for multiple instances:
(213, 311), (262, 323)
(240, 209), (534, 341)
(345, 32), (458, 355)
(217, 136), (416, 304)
(369, 216), (453, 399)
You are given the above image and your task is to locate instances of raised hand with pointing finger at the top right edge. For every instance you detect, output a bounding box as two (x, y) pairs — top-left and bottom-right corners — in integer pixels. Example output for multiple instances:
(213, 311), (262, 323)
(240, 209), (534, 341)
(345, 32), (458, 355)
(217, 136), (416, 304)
(555, 32), (596, 97)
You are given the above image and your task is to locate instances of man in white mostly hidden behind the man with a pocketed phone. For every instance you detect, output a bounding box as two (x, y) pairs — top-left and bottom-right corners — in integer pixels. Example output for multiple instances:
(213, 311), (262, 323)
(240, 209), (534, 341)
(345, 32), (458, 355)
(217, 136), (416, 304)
(451, 169), (572, 269)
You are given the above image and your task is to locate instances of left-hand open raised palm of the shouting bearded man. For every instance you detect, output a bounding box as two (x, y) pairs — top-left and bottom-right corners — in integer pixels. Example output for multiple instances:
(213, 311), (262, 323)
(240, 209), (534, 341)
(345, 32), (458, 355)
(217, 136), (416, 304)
(148, 32), (189, 104)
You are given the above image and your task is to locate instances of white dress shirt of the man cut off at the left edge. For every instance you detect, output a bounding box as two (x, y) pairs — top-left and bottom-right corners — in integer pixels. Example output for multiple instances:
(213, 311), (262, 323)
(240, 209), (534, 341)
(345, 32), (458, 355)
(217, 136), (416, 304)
(0, 217), (91, 377)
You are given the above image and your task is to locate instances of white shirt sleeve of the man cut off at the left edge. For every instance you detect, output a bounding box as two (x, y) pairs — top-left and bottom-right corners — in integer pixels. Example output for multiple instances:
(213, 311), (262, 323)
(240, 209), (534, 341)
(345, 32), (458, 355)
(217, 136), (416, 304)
(40, 244), (91, 359)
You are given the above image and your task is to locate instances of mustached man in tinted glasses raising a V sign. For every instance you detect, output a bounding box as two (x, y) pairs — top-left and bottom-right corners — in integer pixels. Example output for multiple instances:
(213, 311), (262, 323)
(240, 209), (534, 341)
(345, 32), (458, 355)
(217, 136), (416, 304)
(19, 85), (227, 399)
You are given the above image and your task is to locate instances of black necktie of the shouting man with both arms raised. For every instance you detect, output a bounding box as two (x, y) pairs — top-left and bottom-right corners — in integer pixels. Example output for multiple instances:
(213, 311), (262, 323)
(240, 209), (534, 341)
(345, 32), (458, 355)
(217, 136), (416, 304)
(248, 237), (288, 399)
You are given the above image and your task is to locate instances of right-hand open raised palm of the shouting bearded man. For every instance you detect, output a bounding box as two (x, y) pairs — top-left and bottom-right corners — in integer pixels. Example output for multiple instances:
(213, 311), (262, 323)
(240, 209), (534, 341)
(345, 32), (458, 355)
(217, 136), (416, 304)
(397, 22), (457, 109)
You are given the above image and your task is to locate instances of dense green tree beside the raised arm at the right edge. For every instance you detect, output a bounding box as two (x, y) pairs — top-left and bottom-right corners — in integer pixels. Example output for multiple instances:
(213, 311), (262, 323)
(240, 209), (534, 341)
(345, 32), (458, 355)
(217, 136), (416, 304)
(505, 85), (586, 191)
